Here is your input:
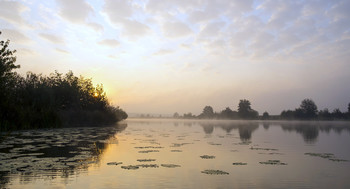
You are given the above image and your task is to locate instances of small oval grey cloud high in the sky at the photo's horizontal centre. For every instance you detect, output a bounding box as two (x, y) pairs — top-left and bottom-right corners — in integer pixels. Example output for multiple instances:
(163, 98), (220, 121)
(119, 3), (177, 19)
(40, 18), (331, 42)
(163, 21), (192, 38)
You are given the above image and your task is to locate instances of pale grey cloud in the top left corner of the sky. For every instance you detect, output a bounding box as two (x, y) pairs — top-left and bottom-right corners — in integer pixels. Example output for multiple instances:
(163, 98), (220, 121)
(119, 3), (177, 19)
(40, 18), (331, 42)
(0, 1), (28, 24)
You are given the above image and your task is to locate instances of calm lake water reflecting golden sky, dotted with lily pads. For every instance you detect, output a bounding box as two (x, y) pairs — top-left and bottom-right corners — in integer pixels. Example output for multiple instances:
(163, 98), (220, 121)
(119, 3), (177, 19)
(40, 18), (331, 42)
(0, 119), (350, 189)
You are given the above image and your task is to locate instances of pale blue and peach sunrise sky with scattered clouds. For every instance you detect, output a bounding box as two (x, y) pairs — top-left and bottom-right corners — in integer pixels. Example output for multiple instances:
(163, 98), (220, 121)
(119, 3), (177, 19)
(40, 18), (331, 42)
(0, 0), (350, 114)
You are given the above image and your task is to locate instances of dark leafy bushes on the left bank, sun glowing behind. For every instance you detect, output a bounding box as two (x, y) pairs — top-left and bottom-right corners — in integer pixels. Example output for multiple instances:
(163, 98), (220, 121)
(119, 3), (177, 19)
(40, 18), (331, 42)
(0, 32), (128, 131)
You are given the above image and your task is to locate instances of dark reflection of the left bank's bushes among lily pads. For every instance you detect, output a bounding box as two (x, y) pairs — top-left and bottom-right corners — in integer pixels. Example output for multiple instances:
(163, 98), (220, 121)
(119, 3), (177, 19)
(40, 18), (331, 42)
(0, 123), (127, 188)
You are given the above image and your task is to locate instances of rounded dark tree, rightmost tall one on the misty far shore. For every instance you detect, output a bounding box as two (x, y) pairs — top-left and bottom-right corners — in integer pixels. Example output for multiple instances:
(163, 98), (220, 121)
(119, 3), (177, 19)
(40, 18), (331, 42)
(296, 99), (317, 119)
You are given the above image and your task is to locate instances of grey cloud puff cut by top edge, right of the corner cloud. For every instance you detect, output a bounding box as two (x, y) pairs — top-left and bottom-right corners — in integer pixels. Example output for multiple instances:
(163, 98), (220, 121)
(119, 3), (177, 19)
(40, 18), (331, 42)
(56, 0), (93, 23)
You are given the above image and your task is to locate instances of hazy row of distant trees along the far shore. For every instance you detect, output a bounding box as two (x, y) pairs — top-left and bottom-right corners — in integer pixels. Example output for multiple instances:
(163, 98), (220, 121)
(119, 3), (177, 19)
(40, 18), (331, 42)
(173, 99), (350, 120)
